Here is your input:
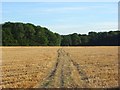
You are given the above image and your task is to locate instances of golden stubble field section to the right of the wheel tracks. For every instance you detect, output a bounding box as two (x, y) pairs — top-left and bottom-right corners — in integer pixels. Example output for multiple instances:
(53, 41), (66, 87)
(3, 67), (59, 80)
(64, 47), (119, 88)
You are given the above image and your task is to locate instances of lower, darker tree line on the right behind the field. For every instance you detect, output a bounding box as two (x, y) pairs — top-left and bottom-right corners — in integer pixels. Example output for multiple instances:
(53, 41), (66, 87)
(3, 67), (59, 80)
(61, 31), (120, 46)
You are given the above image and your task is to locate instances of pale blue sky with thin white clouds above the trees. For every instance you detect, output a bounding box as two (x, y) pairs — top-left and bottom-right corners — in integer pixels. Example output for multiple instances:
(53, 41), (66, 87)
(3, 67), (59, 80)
(2, 2), (118, 35)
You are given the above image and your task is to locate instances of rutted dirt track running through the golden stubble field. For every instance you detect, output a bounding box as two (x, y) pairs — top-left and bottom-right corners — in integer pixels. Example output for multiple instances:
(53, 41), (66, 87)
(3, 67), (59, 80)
(35, 48), (89, 88)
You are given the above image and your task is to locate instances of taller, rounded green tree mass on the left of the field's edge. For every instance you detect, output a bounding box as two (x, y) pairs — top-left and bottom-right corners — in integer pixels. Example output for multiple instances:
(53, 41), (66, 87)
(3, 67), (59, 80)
(2, 22), (61, 46)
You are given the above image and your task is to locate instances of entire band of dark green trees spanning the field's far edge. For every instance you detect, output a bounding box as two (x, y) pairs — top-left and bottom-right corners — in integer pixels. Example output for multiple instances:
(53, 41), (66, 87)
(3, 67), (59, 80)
(1, 22), (120, 46)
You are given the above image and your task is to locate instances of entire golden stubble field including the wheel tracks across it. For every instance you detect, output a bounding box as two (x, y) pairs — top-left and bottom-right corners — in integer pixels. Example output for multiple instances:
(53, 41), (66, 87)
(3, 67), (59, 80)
(0, 46), (118, 88)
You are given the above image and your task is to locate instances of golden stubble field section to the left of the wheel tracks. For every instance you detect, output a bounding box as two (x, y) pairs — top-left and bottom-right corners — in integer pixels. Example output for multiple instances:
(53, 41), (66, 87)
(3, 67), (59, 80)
(2, 47), (57, 88)
